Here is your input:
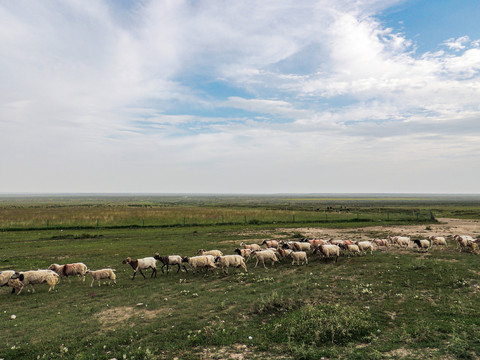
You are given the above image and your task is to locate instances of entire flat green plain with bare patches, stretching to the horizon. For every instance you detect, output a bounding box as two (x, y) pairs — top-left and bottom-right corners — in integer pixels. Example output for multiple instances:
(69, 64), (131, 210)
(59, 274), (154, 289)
(0, 195), (480, 359)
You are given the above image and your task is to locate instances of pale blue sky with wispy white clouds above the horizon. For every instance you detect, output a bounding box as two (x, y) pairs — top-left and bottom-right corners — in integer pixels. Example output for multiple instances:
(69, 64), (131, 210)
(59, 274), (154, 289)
(0, 0), (480, 194)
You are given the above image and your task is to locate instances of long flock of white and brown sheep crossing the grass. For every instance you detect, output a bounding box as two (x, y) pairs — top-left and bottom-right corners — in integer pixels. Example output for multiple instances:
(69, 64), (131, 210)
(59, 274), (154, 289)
(0, 235), (478, 295)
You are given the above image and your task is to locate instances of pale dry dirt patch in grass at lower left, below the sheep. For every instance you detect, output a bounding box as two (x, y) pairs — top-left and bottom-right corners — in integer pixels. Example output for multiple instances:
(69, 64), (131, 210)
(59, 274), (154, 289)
(97, 306), (168, 330)
